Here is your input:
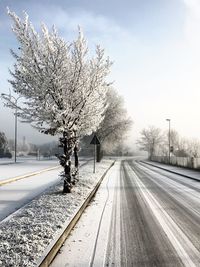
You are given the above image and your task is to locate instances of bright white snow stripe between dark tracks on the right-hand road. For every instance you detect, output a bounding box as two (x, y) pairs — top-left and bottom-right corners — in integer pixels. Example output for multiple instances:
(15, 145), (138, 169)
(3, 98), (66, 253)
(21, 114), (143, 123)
(126, 164), (200, 267)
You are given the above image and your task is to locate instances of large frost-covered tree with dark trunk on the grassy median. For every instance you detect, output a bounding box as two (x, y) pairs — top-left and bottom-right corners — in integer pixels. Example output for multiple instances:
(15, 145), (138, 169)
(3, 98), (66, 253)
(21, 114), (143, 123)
(6, 11), (112, 192)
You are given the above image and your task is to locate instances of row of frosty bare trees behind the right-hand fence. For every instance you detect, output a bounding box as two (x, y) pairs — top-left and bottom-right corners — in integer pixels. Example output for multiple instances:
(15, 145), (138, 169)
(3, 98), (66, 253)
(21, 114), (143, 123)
(137, 126), (200, 158)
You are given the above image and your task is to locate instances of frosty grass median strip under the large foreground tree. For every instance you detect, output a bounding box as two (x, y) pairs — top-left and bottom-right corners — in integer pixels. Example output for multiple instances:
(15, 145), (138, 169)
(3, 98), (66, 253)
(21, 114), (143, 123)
(0, 160), (113, 267)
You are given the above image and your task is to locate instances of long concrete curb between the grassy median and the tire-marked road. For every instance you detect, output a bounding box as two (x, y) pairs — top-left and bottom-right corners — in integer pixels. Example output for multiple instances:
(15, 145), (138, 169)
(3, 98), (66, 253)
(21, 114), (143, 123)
(37, 161), (115, 267)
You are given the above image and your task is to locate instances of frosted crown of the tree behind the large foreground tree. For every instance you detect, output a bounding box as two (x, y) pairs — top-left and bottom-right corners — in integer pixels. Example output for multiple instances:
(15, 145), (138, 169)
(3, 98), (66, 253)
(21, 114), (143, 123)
(96, 88), (132, 153)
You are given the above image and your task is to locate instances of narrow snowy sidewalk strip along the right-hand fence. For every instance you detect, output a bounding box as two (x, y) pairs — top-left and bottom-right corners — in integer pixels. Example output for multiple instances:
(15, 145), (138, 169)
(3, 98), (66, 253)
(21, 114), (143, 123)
(141, 160), (200, 181)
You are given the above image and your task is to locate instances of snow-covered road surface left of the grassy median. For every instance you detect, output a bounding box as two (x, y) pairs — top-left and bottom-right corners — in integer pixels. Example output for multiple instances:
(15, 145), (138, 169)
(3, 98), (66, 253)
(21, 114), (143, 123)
(0, 158), (86, 221)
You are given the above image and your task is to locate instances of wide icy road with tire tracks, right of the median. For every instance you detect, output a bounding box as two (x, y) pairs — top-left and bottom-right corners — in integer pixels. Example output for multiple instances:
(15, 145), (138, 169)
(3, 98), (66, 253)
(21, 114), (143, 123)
(51, 161), (200, 267)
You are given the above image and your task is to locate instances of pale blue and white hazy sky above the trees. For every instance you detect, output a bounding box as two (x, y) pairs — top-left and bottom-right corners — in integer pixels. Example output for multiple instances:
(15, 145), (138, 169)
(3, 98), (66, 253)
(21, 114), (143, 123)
(0, 0), (200, 147)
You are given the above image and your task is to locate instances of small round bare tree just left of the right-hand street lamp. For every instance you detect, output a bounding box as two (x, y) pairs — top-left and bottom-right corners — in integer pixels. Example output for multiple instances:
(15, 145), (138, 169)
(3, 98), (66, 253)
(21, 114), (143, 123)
(137, 126), (163, 159)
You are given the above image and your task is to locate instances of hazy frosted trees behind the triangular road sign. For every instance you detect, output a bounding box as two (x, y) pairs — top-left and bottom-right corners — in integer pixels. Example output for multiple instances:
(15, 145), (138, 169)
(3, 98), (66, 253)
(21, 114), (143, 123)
(81, 88), (133, 160)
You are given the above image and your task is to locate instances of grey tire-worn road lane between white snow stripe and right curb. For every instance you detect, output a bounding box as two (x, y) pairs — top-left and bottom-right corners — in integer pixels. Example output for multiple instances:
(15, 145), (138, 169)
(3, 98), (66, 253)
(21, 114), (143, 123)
(130, 163), (200, 253)
